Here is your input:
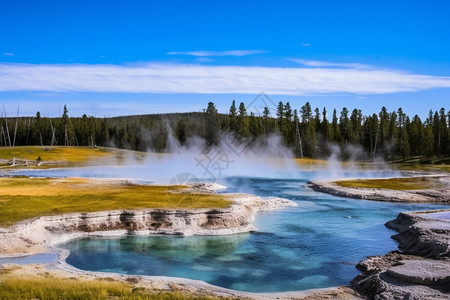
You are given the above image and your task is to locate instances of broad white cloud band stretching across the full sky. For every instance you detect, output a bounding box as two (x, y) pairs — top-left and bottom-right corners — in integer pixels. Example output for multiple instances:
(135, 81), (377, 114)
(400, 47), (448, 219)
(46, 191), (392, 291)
(0, 63), (450, 96)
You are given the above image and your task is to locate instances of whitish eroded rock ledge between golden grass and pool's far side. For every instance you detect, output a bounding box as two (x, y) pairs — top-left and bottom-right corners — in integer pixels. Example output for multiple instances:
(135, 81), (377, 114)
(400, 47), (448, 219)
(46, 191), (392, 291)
(0, 194), (296, 256)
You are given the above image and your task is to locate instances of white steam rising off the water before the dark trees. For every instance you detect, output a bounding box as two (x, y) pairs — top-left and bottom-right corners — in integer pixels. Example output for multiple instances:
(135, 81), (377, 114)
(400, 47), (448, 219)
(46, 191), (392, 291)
(17, 126), (399, 185)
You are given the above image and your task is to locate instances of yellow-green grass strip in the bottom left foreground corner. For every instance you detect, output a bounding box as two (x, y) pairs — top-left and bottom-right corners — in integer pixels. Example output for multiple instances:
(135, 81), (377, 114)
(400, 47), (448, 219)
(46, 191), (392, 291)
(0, 277), (225, 300)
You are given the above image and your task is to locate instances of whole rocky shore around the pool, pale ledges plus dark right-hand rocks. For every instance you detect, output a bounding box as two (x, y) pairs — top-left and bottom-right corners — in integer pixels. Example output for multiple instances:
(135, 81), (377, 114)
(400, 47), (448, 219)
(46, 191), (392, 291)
(0, 179), (450, 299)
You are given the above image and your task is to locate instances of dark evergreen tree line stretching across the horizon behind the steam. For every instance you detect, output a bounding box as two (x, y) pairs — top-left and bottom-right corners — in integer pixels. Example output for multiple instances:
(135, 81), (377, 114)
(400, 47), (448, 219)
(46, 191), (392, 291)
(0, 100), (450, 159)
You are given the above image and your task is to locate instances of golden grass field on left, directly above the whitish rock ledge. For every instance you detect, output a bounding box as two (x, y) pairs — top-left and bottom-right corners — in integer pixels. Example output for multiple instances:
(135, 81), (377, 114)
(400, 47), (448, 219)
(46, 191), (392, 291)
(0, 177), (231, 226)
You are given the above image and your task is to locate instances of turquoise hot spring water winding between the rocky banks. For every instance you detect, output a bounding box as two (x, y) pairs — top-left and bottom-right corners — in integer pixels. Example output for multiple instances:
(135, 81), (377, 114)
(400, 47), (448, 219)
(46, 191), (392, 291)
(61, 177), (441, 292)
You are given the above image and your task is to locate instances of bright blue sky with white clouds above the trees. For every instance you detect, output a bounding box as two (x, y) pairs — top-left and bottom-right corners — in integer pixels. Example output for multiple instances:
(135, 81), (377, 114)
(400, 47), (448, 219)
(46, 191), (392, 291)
(0, 0), (450, 118)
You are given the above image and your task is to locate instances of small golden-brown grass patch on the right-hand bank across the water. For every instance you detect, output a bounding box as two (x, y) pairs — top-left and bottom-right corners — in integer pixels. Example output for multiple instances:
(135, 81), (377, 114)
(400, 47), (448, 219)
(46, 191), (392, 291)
(335, 177), (443, 191)
